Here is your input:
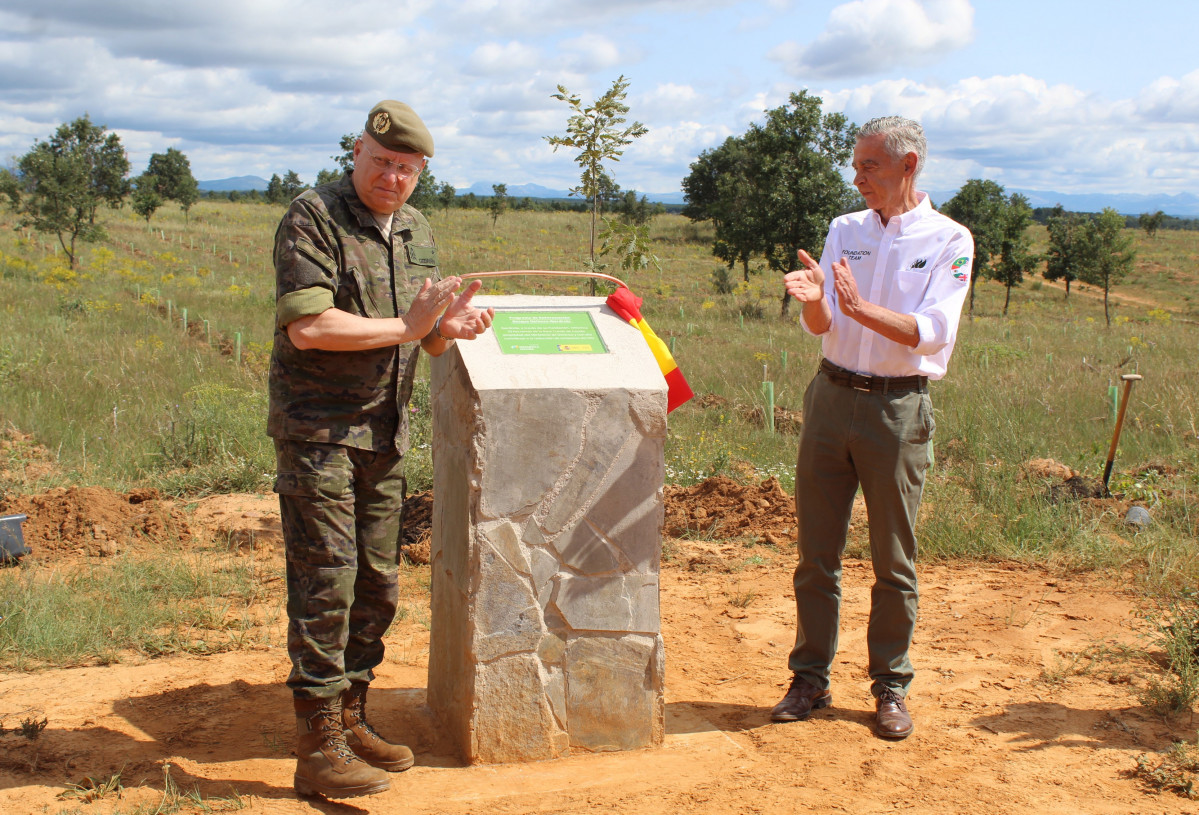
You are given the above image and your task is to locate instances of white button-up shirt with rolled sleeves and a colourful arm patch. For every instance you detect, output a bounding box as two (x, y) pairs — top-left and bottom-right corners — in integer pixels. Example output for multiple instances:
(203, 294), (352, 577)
(800, 193), (974, 379)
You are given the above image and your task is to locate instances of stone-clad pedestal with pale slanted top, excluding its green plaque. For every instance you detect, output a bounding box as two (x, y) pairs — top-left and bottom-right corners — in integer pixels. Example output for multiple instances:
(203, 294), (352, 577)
(428, 296), (667, 762)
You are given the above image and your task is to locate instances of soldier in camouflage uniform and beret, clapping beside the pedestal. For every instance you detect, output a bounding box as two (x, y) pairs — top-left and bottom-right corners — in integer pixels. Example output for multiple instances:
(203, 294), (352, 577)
(267, 99), (493, 797)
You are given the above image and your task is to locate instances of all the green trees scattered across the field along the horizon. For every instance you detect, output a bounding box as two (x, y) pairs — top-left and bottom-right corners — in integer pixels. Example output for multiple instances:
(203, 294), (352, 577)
(0, 106), (1151, 321)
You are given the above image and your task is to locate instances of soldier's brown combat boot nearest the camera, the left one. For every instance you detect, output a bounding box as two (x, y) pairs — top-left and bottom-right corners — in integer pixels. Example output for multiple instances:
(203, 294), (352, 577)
(294, 698), (391, 798)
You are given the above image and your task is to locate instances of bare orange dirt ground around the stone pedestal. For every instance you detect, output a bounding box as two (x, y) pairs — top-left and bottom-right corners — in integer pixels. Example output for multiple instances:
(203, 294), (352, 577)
(0, 481), (1197, 815)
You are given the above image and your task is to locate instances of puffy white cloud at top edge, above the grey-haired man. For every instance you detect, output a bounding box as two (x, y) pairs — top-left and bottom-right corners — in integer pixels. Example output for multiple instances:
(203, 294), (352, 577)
(770, 0), (974, 79)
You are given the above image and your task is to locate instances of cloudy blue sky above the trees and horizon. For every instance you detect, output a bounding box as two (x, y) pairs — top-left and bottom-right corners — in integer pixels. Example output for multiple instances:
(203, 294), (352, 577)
(0, 0), (1199, 194)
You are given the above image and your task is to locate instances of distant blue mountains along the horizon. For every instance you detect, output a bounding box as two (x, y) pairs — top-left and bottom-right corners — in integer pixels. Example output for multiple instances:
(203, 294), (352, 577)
(199, 175), (1199, 218)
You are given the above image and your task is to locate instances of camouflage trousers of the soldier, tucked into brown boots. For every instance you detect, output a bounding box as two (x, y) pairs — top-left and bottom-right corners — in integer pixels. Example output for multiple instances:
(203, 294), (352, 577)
(275, 439), (405, 699)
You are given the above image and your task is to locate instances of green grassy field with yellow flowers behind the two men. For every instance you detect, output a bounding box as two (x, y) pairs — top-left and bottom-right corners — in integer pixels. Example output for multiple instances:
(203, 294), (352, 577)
(0, 201), (1199, 585)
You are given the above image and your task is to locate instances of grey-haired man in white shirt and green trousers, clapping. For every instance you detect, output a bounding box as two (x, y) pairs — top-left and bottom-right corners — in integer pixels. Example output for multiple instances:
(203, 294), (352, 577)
(771, 116), (974, 738)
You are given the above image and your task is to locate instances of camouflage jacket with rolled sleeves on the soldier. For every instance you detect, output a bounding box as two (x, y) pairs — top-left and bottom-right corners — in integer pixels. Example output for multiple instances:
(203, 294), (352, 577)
(266, 175), (440, 453)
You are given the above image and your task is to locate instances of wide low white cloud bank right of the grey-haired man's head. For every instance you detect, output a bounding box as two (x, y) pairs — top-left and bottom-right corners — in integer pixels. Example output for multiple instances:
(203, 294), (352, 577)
(823, 72), (1199, 192)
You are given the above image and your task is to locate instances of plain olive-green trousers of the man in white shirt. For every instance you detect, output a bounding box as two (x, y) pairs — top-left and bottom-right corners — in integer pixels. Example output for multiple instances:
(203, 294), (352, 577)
(788, 374), (935, 696)
